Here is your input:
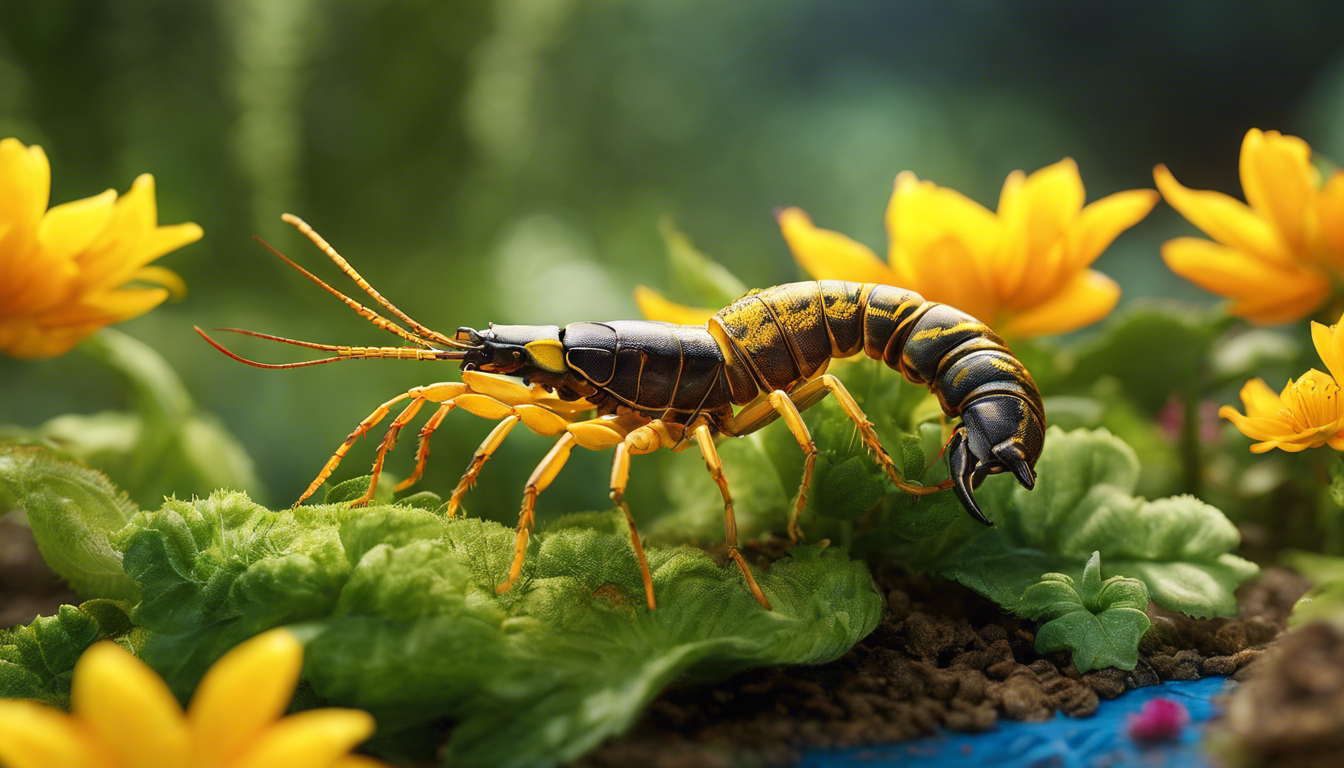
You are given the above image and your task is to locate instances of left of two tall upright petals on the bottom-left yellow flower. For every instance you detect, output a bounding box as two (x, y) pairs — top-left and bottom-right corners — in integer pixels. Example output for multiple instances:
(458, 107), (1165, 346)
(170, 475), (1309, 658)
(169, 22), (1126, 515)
(70, 642), (190, 768)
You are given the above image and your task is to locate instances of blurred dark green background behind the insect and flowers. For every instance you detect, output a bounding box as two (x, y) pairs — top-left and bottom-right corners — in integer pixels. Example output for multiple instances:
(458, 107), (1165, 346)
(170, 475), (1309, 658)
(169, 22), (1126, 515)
(0, 0), (1344, 519)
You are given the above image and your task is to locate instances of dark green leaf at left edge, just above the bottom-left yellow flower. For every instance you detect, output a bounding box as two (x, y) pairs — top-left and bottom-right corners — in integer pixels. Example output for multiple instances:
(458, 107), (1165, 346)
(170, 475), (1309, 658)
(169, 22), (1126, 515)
(0, 600), (132, 707)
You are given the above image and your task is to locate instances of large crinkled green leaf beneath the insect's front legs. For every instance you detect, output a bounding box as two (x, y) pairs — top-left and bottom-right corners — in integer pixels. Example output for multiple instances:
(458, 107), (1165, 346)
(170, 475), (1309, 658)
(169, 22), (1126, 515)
(118, 489), (882, 765)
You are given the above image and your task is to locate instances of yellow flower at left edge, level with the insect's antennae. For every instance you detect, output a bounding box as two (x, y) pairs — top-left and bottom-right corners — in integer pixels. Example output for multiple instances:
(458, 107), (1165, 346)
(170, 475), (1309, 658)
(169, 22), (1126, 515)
(0, 139), (202, 358)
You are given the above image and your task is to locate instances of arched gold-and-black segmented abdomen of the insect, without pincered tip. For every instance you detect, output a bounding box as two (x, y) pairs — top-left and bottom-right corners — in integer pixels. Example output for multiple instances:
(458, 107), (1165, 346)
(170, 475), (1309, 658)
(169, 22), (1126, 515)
(710, 280), (1043, 425)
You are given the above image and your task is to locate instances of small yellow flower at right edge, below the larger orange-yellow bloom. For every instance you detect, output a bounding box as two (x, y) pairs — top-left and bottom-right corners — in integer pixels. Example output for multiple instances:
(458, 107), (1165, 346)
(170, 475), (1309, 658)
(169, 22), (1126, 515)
(1218, 309), (1344, 453)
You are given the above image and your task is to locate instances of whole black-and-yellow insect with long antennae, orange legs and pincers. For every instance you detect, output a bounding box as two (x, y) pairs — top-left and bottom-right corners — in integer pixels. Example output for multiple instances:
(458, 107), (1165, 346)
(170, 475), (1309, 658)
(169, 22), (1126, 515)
(196, 214), (1046, 609)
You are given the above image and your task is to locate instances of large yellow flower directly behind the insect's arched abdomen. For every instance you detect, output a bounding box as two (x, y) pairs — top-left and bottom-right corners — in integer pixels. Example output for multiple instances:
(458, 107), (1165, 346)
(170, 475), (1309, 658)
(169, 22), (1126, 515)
(636, 159), (1157, 336)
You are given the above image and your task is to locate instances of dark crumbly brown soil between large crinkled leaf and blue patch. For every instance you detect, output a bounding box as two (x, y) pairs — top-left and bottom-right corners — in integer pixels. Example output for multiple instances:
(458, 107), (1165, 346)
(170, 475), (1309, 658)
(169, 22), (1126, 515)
(577, 559), (1311, 768)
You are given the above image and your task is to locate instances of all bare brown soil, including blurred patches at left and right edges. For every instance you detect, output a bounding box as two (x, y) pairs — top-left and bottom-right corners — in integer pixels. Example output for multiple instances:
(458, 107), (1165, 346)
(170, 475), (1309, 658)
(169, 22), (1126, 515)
(0, 518), (1317, 768)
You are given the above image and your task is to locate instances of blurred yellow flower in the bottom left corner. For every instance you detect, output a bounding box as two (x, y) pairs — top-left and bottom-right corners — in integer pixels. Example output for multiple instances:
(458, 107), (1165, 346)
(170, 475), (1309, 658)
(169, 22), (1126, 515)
(0, 629), (383, 768)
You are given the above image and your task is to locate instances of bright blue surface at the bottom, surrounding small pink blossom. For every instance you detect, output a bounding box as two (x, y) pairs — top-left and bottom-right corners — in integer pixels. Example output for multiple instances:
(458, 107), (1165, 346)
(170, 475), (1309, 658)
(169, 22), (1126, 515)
(802, 678), (1230, 768)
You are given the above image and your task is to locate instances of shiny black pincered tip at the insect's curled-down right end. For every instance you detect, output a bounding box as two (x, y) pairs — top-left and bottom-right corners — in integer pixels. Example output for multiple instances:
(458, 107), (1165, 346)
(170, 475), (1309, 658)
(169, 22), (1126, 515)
(948, 394), (1046, 526)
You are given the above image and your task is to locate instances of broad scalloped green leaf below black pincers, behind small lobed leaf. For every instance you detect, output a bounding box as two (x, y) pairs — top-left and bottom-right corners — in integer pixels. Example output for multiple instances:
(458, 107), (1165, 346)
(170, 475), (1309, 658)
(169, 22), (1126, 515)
(887, 428), (1258, 617)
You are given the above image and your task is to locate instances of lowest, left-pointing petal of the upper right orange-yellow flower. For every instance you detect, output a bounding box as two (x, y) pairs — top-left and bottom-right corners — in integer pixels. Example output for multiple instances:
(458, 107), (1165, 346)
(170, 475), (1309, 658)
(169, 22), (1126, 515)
(1163, 237), (1331, 324)
